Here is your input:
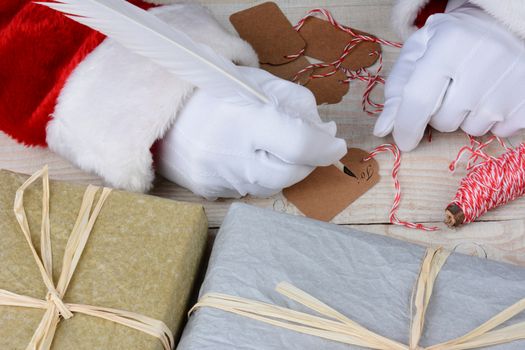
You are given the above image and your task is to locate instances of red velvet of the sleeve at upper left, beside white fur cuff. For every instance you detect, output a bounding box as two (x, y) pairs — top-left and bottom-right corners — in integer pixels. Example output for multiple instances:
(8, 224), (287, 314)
(0, 0), (152, 146)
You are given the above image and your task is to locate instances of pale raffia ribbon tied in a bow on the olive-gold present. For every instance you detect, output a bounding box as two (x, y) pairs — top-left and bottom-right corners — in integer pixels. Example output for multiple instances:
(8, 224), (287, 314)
(0, 166), (174, 350)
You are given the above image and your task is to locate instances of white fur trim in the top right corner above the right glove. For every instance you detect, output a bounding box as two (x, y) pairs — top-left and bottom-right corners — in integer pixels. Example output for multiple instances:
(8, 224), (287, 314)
(470, 0), (525, 39)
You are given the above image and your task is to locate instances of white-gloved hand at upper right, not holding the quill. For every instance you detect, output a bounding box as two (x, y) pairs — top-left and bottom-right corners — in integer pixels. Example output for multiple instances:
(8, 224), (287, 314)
(374, 5), (525, 151)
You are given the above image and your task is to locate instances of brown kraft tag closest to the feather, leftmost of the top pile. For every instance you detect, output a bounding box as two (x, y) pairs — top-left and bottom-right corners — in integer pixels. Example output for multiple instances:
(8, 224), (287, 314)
(230, 2), (306, 65)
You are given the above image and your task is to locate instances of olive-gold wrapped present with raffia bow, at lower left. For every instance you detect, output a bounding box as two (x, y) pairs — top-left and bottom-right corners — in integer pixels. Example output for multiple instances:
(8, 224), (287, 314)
(0, 168), (207, 350)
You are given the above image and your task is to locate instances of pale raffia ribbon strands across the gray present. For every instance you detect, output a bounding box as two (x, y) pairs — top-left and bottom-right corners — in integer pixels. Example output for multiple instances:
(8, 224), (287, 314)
(190, 248), (525, 350)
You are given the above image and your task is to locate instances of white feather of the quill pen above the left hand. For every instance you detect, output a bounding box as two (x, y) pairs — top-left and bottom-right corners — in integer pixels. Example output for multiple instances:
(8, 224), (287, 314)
(36, 0), (269, 104)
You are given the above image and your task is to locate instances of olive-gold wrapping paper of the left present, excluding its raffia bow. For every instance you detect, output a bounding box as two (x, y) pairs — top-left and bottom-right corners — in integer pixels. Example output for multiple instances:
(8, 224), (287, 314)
(0, 171), (207, 350)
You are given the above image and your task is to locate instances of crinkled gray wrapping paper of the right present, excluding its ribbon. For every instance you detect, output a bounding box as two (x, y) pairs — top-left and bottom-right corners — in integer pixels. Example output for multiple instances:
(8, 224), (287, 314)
(177, 204), (525, 350)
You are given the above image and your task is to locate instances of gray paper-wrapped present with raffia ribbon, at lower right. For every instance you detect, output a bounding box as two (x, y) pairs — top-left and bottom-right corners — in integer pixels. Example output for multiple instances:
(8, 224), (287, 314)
(178, 204), (525, 350)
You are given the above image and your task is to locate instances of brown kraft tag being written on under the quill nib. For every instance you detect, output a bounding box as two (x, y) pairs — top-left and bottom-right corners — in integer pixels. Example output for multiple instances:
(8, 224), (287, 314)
(283, 148), (379, 221)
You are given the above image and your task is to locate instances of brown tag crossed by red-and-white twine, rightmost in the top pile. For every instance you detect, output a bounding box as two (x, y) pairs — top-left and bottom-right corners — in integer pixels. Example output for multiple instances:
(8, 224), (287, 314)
(300, 17), (381, 70)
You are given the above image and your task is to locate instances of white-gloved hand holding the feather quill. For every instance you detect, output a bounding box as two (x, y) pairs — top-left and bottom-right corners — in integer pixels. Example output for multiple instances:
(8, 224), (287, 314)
(157, 67), (346, 199)
